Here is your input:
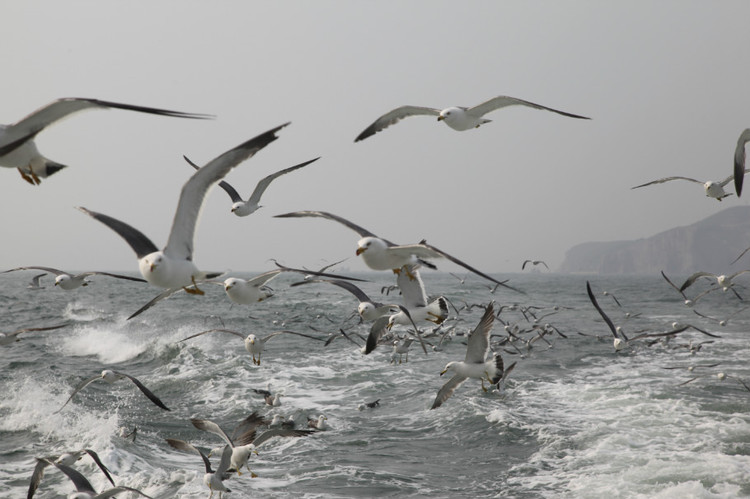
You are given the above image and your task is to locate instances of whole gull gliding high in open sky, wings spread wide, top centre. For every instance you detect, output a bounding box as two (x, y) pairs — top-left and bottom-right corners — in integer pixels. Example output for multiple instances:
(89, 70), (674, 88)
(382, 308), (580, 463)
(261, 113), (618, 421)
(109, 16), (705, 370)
(354, 95), (591, 142)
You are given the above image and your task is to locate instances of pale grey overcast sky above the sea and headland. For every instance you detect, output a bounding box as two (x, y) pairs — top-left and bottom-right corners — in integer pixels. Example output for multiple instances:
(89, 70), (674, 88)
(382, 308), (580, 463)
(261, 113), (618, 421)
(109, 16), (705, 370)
(0, 0), (750, 278)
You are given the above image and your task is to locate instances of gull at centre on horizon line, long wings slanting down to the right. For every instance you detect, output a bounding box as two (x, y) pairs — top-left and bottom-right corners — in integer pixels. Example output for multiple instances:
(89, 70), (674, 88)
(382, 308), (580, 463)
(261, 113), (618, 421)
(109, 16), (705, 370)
(275, 211), (521, 292)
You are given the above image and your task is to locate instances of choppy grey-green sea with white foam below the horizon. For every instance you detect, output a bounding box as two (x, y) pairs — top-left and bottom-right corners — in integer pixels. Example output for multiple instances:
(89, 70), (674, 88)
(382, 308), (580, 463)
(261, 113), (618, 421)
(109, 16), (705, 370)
(0, 271), (750, 499)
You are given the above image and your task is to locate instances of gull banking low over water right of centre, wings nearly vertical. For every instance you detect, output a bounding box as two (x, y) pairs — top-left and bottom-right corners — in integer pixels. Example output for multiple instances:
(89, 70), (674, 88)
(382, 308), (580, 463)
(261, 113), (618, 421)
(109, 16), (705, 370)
(430, 303), (504, 409)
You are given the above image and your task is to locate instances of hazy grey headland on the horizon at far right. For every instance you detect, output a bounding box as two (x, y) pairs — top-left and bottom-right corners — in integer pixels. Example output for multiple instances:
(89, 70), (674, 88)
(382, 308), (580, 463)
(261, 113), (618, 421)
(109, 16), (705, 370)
(558, 206), (750, 274)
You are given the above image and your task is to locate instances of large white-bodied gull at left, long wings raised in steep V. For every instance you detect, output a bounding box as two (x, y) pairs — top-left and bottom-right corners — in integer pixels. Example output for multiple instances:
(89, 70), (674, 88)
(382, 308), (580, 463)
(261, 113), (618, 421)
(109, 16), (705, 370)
(78, 123), (288, 318)
